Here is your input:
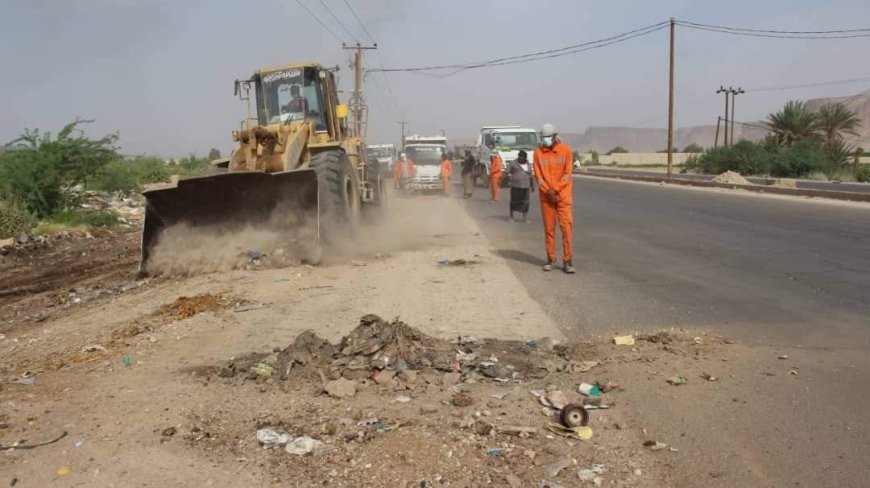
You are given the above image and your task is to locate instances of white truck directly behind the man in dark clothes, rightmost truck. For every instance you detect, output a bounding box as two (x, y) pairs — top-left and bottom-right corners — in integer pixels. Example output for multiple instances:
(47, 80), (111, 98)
(473, 125), (538, 187)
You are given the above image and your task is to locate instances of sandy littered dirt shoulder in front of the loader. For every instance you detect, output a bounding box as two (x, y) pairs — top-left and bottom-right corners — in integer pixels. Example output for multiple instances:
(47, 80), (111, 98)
(0, 197), (756, 487)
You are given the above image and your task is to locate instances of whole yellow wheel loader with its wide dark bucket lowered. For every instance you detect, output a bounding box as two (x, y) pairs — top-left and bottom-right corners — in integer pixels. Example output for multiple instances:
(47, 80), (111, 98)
(139, 63), (385, 274)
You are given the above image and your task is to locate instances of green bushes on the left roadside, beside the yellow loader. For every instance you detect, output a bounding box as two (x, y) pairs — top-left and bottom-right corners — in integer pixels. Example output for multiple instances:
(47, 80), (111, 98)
(0, 120), (220, 239)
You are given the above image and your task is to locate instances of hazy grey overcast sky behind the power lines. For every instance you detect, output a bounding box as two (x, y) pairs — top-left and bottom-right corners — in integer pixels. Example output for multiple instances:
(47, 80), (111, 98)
(0, 0), (870, 157)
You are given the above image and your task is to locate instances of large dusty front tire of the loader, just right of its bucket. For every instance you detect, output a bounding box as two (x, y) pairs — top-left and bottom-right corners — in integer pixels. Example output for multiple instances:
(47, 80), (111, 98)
(311, 149), (360, 236)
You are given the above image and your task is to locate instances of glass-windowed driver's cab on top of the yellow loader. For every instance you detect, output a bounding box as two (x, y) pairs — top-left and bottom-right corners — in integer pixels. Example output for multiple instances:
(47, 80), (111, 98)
(253, 65), (339, 137)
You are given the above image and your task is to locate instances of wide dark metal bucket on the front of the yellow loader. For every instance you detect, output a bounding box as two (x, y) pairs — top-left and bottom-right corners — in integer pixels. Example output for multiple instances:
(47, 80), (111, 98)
(139, 169), (320, 273)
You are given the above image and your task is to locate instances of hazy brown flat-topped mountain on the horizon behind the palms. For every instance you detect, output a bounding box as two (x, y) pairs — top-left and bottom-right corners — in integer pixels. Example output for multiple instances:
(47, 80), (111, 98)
(560, 94), (870, 152)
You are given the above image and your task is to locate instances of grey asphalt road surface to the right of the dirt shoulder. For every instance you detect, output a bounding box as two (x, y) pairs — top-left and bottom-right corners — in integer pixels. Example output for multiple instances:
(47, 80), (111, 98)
(456, 177), (870, 486)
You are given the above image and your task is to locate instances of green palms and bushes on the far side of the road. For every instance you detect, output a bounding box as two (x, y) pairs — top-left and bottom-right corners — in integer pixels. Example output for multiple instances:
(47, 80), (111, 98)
(686, 101), (870, 181)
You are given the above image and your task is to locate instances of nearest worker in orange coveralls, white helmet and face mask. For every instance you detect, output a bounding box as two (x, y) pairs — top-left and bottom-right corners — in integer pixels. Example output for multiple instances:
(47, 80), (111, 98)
(535, 124), (576, 274)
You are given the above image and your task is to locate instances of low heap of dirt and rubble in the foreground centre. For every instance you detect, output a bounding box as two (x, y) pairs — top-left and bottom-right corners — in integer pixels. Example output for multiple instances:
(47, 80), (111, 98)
(220, 315), (597, 393)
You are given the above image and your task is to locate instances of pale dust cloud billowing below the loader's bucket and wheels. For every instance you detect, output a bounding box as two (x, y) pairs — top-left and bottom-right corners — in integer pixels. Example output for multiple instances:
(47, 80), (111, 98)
(144, 190), (464, 276)
